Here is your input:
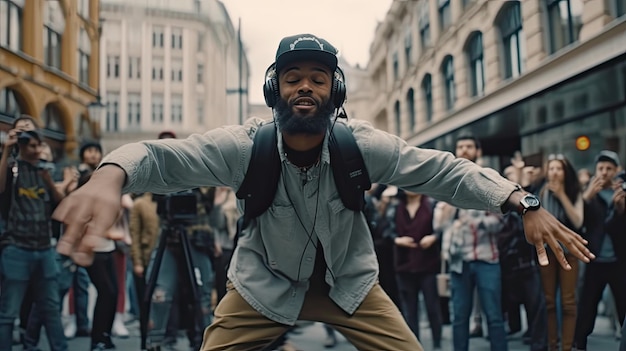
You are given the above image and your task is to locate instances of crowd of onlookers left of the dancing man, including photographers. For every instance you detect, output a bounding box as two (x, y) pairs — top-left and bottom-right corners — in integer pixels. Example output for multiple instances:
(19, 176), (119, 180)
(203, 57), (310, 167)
(0, 115), (238, 351)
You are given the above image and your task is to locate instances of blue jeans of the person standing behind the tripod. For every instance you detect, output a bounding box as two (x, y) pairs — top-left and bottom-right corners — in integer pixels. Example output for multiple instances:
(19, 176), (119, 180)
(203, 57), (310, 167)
(147, 245), (214, 347)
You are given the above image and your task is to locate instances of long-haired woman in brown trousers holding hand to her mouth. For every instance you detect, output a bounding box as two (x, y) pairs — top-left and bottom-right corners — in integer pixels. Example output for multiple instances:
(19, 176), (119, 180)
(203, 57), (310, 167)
(539, 154), (587, 350)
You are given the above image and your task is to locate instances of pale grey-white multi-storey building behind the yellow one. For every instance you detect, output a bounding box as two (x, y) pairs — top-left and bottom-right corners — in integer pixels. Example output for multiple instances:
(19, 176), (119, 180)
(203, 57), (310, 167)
(101, 0), (249, 150)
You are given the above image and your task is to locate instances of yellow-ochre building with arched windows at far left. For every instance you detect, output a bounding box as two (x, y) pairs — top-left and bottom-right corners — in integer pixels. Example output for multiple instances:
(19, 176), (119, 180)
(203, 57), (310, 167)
(0, 0), (100, 160)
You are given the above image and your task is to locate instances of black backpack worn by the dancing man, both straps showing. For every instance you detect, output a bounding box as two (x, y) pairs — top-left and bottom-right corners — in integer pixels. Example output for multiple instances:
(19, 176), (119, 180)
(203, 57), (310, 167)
(236, 122), (372, 230)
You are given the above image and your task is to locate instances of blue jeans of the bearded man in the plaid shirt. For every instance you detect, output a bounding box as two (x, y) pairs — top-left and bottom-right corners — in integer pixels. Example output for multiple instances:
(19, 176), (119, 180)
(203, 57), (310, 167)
(450, 261), (508, 351)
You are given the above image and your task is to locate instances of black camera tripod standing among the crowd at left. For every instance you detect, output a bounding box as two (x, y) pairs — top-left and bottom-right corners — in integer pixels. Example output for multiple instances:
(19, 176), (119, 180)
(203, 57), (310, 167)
(139, 221), (203, 351)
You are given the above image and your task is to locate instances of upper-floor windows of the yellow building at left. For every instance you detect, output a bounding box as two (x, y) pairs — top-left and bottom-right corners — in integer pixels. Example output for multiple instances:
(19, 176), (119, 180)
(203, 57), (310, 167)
(0, 0), (91, 84)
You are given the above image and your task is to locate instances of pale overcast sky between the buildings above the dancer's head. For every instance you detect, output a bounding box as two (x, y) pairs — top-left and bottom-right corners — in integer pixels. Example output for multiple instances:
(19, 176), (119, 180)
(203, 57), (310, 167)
(222, 0), (392, 103)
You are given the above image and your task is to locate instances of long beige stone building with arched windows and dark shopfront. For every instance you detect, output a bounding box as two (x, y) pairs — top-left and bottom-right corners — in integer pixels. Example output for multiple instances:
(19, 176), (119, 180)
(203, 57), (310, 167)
(368, 0), (626, 169)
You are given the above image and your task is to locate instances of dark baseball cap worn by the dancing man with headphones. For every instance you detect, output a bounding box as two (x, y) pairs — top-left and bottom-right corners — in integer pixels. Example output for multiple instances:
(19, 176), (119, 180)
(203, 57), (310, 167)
(276, 34), (338, 72)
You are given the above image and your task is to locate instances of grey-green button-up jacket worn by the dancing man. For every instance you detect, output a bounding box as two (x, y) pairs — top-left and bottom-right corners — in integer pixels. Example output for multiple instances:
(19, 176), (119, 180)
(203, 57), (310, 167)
(103, 118), (515, 325)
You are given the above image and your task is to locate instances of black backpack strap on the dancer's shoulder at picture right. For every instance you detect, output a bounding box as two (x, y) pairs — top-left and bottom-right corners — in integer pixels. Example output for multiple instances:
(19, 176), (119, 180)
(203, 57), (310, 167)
(328, 123), (372, 211)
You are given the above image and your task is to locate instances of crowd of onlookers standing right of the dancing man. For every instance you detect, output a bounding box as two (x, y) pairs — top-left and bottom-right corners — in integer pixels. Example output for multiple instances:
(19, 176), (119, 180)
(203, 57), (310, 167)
(369, 135), (626, 351)
